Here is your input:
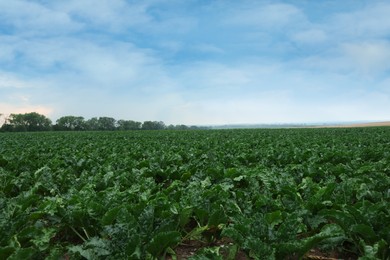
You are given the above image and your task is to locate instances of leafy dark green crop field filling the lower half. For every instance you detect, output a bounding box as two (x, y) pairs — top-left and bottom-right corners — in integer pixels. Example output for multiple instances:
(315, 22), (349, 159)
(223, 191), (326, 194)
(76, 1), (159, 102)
(0, 127), (390, 259)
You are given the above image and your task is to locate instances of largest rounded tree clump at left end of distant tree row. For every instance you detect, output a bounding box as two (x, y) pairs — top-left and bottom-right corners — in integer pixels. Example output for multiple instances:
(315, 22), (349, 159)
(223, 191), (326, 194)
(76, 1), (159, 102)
(6, 112), (52, 132)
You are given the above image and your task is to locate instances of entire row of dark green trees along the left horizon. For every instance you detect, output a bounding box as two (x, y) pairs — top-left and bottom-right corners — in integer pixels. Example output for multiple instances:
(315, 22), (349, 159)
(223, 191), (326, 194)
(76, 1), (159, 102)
(0, 112), (203, 132)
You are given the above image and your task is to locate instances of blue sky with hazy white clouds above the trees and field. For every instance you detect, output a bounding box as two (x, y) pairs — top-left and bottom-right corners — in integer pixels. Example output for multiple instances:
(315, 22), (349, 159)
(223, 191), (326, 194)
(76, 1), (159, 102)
(0, 0), (390, 125)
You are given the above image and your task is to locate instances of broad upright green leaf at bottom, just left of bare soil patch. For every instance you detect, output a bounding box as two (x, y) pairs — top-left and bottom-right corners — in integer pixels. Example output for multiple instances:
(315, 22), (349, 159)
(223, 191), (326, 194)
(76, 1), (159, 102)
(146, 231), (181, 257)
